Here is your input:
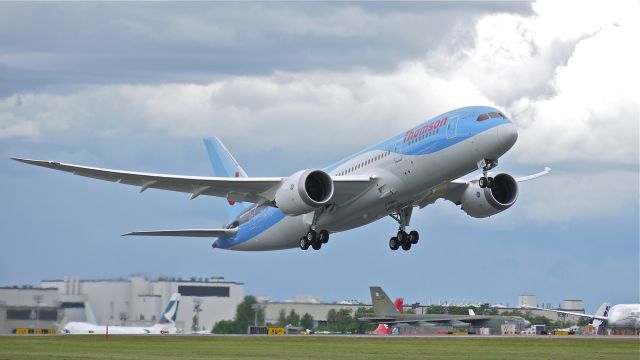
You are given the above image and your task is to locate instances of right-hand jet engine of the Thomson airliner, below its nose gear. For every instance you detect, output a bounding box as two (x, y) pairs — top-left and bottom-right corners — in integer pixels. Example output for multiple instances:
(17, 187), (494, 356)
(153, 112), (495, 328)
(461, 173), (518, 218)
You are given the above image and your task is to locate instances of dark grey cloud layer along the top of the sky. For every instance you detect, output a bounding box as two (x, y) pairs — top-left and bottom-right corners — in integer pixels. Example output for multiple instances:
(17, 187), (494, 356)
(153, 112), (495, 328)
(0, 2), (531, 96)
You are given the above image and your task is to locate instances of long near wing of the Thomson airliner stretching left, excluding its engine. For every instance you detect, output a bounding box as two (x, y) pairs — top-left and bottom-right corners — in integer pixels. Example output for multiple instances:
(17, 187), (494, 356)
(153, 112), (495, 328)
(11, 158), (374, 205)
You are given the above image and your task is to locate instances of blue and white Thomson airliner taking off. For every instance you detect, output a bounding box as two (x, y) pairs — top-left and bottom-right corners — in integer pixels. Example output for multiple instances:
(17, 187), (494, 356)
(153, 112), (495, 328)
(12, 106), (551, 251)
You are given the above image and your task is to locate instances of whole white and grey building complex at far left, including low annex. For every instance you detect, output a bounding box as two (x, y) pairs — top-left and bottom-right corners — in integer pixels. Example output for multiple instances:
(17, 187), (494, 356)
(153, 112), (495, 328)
(0, 275), (244, 334)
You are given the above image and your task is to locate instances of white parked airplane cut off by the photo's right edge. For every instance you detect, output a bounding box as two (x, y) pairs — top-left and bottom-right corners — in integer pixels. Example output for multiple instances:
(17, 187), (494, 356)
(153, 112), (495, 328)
(523, 303), (640, 334)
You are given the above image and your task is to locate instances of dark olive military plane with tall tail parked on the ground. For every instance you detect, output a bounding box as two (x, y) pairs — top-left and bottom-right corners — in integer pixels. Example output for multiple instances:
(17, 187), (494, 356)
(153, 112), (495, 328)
(359, 286), (531, 328)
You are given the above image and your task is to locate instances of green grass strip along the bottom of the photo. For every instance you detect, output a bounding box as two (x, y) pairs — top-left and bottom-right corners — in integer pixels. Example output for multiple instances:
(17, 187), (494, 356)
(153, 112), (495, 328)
(0, 335), (640, 360)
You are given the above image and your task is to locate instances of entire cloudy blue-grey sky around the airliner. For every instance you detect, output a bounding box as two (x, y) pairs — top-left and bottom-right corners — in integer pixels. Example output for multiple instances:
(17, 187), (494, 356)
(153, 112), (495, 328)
(0, 1), (640, 312)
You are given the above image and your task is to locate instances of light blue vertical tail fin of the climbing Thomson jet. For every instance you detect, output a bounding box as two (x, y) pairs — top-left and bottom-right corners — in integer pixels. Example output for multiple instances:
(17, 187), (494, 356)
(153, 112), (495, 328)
(203, 136), (249, 220)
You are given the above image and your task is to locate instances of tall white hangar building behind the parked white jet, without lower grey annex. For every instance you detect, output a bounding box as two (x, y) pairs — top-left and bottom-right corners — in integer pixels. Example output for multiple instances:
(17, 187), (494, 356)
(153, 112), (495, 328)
(42, 275), (244, 333)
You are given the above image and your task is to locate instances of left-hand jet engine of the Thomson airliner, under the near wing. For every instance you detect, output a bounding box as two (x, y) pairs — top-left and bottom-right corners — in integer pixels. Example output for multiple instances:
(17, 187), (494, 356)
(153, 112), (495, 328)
(275, 169), (333, 216)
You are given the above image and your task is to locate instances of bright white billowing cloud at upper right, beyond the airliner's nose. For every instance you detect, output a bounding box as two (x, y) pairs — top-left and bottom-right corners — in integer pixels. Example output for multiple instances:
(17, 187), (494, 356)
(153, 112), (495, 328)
(444, 1), (640, 165)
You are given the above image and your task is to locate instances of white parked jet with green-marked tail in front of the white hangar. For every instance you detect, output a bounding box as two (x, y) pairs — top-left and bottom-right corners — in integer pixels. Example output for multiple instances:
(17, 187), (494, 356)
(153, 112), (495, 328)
(63, 293), (180, 334)
